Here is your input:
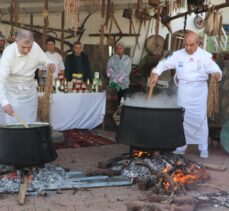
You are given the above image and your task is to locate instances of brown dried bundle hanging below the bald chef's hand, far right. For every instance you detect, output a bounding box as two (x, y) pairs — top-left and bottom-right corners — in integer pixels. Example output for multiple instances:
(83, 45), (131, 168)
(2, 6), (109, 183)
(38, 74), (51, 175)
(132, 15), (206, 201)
(208, 76), (219, 119)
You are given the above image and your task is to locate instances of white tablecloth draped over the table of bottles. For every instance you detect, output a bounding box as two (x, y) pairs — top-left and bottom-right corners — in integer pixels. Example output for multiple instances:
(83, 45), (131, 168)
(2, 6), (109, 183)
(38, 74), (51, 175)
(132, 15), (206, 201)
(0, 92), (106, 131)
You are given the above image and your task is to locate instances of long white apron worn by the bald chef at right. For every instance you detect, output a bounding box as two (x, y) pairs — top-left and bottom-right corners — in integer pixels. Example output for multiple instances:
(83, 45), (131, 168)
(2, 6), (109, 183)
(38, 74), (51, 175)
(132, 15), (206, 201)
(178, 80), (208, 151)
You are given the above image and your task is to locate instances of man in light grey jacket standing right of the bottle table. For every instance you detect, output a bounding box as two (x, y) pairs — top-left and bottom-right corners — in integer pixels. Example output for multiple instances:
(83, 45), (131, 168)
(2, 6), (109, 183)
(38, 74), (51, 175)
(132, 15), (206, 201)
(107, 43), (132, 102)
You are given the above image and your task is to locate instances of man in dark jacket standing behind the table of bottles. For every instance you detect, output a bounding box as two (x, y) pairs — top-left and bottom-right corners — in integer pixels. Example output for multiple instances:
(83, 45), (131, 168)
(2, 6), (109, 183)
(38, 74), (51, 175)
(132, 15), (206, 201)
(64, 42), (94, 83)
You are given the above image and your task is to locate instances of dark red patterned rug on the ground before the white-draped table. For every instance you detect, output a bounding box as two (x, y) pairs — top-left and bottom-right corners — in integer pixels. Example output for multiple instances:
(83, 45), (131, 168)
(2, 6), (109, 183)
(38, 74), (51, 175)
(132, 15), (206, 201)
(53, 129), (114, 149)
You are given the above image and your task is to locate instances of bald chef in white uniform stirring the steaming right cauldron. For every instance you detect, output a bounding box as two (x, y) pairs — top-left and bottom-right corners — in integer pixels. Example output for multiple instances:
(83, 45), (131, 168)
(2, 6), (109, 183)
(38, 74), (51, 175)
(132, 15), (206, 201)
(150, 32), (222, 158)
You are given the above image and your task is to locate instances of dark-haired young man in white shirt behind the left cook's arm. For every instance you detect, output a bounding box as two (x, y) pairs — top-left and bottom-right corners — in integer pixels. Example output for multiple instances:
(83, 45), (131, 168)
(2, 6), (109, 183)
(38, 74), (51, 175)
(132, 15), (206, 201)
(38, 38), (64, 79)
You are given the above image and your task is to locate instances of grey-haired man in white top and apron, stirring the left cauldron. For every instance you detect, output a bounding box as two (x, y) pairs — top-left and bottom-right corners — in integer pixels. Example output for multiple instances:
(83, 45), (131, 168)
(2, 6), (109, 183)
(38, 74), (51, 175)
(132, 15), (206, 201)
(0, 30), (55, 123)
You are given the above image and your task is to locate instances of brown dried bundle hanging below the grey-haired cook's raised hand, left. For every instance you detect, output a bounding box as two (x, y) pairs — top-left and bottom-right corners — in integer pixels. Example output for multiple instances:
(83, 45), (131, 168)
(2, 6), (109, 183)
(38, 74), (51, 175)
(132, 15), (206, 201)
(37, 67), (53, 122)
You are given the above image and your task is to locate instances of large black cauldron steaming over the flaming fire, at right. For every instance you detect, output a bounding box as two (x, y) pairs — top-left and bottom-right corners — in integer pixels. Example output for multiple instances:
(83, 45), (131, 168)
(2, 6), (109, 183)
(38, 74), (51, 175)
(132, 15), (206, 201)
(116, 105), (185, 151)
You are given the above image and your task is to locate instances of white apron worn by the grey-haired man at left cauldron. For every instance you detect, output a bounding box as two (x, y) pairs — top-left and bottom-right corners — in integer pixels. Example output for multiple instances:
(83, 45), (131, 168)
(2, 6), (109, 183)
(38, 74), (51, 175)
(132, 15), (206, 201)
(5, 75), (38, 123)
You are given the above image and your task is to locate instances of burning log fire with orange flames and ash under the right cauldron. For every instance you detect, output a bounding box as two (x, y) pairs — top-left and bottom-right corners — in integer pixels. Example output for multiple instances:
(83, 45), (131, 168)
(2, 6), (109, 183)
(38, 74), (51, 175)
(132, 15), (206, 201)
(106, 150), (209, 194)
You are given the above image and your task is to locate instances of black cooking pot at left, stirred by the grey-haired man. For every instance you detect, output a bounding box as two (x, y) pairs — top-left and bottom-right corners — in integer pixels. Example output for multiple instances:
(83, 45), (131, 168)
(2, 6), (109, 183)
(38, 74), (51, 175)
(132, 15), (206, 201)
(0, 123), (57, 167)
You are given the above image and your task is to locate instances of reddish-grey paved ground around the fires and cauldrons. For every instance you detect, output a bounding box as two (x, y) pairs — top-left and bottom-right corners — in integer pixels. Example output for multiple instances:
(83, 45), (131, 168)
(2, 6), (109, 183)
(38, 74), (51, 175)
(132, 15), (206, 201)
(0, 130), (229, 211)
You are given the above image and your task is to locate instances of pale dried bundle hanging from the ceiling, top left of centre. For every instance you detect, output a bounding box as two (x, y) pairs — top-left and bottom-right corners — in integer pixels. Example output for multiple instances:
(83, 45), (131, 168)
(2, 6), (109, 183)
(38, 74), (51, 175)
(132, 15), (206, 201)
(64, 0), (80, 32)
